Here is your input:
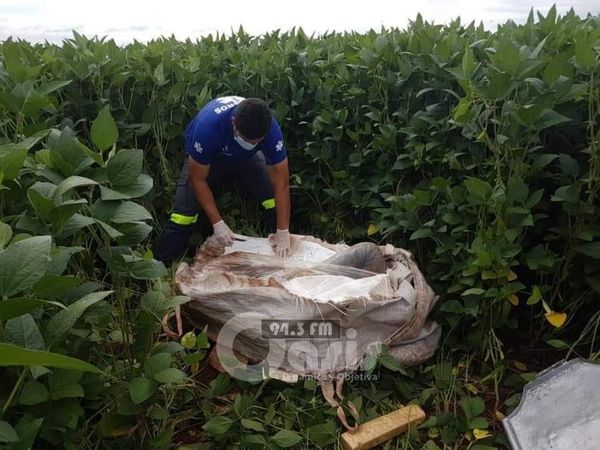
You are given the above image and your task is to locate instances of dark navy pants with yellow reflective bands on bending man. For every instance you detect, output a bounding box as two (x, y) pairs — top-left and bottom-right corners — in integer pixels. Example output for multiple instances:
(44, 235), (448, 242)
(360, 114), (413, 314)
(154, 152), (275, 265)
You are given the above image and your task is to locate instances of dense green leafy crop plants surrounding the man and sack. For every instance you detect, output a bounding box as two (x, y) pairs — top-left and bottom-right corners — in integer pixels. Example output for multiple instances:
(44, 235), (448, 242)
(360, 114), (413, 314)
(0, 9), (600, 450)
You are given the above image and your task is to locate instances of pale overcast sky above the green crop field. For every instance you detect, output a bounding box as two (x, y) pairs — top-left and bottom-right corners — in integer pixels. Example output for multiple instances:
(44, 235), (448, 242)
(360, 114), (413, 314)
(0, 0), (600, 43)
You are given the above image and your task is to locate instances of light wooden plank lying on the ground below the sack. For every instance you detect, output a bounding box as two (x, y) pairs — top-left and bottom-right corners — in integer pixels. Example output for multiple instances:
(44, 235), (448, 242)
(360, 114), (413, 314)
(341, 405), (425, 450)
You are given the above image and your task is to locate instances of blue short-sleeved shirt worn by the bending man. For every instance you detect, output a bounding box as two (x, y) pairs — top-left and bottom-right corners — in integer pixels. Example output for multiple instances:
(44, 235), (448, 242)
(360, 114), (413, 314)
(185, 96), (287, 166)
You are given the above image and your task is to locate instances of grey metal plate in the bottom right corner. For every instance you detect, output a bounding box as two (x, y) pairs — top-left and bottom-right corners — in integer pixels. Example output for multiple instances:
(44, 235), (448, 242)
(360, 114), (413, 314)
(503, 359), (600, 450)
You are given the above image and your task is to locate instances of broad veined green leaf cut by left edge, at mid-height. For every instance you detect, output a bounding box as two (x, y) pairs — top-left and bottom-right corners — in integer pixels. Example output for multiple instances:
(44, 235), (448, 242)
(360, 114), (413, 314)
(0, 236), (52, 297)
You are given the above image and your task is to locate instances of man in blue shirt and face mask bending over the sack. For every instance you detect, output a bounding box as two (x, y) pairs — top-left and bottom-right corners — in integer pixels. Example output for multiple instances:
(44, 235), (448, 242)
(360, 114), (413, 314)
(155, 96), (291, 264)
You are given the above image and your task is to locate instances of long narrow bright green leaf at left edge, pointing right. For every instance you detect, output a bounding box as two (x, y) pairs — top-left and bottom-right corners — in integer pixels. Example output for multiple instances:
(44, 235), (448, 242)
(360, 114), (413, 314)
(0, 343), (100, 373)
